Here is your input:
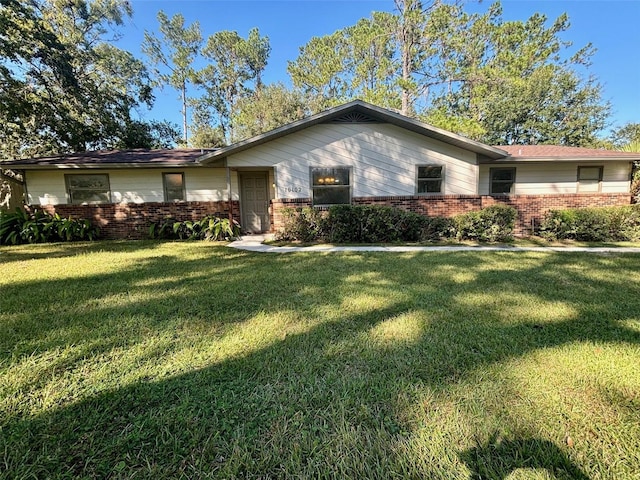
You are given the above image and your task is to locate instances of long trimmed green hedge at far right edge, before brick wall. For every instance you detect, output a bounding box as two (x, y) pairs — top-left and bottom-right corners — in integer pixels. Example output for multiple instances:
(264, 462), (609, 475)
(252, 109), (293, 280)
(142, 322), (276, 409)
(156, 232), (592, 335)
(538, 205), (640, 242)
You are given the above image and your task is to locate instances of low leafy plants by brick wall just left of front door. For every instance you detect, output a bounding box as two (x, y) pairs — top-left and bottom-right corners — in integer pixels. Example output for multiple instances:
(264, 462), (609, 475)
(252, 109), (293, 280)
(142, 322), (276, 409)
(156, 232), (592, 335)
(149, 215), (240, 241)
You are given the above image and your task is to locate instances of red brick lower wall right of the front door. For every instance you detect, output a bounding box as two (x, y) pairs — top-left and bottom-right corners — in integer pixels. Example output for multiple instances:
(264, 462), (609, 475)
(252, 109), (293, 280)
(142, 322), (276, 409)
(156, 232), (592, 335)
(272, 193), (631, 235)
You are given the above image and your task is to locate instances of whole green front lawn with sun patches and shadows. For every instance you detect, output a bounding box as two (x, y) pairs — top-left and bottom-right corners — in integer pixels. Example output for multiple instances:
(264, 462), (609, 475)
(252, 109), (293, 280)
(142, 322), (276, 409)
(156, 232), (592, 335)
(0, 242), (640, 479)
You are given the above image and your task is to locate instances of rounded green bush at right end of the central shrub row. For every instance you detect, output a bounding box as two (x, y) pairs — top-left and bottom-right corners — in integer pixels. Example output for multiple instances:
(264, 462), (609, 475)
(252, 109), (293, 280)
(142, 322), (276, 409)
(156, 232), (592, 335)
(454, 204), (518, 242)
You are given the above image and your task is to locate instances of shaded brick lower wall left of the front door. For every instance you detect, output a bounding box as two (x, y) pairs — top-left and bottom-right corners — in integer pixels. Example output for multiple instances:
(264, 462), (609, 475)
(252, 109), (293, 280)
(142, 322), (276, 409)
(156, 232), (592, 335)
(38, 201), (240, 239)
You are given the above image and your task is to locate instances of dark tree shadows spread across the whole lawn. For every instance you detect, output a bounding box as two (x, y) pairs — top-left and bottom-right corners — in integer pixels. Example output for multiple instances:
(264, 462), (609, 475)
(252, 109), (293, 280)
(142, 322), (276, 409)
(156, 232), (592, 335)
(0, 249), (640, 478)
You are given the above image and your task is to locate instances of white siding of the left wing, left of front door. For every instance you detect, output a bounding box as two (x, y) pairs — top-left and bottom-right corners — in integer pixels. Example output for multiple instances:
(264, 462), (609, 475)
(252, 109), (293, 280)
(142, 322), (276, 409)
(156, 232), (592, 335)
(26, 168), (239, 205)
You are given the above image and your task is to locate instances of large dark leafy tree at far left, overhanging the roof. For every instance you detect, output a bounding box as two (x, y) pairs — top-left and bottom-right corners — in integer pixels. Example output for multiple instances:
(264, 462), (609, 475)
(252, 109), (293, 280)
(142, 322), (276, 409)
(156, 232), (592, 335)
(0, 0), (179, 158)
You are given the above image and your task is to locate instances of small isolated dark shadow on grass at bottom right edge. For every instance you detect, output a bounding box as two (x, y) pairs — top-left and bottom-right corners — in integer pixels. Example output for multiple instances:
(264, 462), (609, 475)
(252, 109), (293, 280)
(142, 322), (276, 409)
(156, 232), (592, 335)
(460, 433), (589, 480)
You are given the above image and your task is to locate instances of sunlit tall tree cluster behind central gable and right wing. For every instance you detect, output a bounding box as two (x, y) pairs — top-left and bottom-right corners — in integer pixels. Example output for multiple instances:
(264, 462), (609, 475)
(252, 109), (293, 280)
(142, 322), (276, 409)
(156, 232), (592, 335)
(288, 0), (610, 146)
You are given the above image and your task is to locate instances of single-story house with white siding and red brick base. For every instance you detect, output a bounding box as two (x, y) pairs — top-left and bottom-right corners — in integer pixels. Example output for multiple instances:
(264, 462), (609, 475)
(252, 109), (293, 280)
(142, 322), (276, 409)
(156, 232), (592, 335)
(0, 101), (640, 238)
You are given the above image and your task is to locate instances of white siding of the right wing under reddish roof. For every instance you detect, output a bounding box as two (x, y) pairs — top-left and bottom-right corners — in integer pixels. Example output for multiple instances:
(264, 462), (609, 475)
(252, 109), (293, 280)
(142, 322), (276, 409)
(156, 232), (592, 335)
(478, 161), (631, 195)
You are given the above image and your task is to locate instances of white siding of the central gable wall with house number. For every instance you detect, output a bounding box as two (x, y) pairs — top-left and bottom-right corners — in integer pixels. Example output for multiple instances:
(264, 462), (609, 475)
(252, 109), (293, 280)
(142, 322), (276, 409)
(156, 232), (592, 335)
(227, 123), (478, 198)
